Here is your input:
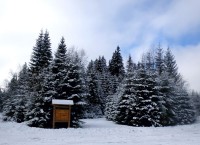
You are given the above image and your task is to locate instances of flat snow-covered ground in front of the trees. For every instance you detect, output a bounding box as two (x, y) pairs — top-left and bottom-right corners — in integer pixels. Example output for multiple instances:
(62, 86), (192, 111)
(0, 115), (200, 145)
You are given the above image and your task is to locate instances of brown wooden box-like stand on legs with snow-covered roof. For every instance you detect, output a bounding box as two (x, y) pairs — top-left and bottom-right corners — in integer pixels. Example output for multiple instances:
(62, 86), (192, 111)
(52, 99), (73, 128)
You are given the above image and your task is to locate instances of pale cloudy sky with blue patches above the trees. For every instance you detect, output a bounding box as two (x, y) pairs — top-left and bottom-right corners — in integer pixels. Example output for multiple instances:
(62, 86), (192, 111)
(0, 0), (200, 91)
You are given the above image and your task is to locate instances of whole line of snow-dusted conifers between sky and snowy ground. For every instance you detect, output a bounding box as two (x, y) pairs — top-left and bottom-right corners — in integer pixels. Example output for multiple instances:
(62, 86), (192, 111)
(0, 31), (200, 128)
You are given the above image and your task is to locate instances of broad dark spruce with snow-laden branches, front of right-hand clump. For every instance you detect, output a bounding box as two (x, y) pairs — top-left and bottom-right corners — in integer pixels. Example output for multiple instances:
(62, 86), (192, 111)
(116, 65), (161, 126)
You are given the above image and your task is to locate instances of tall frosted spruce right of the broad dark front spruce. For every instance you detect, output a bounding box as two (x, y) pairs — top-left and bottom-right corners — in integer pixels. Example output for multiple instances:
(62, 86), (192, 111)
(159, 48), (195, 125)
